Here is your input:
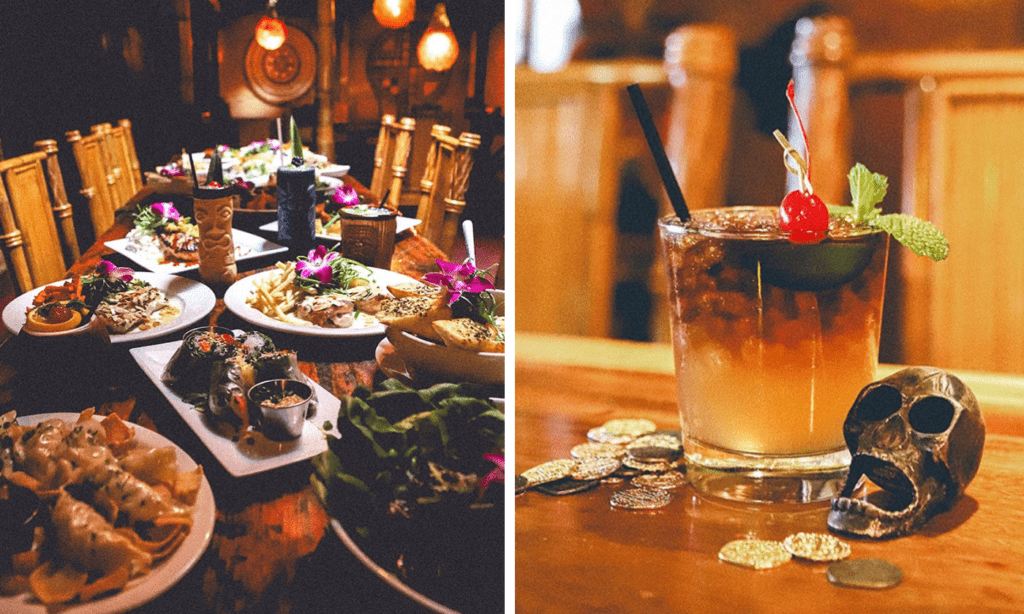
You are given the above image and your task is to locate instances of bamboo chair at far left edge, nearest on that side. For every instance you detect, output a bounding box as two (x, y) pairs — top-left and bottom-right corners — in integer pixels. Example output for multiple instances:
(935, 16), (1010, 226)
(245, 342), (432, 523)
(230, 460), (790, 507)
(0, 139), (81, 292)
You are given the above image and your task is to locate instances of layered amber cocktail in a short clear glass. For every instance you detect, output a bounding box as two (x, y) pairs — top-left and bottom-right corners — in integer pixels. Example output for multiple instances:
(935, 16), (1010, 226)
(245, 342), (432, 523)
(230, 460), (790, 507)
(658, 207), (889, 501)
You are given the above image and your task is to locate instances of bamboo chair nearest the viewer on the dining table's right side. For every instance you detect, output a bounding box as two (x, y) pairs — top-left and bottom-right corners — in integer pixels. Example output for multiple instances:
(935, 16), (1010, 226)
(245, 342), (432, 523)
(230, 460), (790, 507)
(416, 126), (480, 253)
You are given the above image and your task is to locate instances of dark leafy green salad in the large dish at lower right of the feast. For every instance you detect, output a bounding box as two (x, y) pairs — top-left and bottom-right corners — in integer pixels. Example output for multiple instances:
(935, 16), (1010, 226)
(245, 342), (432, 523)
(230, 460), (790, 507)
(310, 380), (505, 537)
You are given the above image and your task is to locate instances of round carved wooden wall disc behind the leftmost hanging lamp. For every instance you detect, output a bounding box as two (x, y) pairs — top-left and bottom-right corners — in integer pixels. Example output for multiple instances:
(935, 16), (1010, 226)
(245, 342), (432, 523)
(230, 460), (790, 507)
(246, 28), (316, 104)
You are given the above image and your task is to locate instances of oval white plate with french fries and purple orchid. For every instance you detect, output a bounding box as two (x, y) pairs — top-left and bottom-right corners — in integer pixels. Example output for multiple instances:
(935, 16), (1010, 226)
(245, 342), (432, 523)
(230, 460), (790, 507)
(224, 246), (418, 337)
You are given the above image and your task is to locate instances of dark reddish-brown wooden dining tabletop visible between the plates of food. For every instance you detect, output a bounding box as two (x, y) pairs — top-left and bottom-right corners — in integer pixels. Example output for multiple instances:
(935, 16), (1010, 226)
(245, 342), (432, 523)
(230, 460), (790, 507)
(0, 189), (475, 613)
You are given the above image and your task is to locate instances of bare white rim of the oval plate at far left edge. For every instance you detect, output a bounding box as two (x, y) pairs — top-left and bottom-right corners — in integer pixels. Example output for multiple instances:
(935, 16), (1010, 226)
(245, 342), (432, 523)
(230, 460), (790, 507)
(3, 271), (217, 343)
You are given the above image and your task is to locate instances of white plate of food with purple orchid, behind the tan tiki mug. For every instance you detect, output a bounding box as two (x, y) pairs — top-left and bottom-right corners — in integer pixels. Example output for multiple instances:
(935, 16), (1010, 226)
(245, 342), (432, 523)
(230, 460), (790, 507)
(103, 203), (288, 273)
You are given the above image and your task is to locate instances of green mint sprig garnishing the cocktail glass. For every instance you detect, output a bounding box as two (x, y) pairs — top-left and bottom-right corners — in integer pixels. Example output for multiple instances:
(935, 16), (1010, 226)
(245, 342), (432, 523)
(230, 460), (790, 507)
(828, 162), (949, 261)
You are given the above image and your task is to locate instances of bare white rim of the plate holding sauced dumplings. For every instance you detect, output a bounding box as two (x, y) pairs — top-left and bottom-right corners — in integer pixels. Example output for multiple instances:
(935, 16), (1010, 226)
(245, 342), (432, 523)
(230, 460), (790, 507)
(0, 413), (217, 614)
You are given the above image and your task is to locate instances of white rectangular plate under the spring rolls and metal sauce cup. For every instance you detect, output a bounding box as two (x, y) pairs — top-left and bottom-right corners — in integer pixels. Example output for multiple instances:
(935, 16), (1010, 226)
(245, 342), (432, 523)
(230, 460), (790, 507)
(131, 341), (341, 477)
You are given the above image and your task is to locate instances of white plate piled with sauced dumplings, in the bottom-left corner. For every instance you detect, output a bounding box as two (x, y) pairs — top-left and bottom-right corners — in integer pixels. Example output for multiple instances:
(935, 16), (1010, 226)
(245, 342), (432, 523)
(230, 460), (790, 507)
(0, 409), (216, 614)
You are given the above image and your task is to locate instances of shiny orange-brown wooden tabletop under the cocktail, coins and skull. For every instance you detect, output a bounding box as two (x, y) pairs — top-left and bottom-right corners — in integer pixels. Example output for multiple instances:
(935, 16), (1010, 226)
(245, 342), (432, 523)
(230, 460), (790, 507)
(515, 333), (1024, 614)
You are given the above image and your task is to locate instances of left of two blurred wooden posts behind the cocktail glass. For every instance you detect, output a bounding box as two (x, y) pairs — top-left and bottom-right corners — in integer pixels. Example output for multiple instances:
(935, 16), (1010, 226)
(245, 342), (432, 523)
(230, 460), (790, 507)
(663, 25), (738, 214)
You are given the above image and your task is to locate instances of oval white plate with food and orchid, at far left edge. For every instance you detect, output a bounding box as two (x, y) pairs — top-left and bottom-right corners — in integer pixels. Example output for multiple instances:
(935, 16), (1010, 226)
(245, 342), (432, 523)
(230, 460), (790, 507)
(2, 260), (217, 343)
